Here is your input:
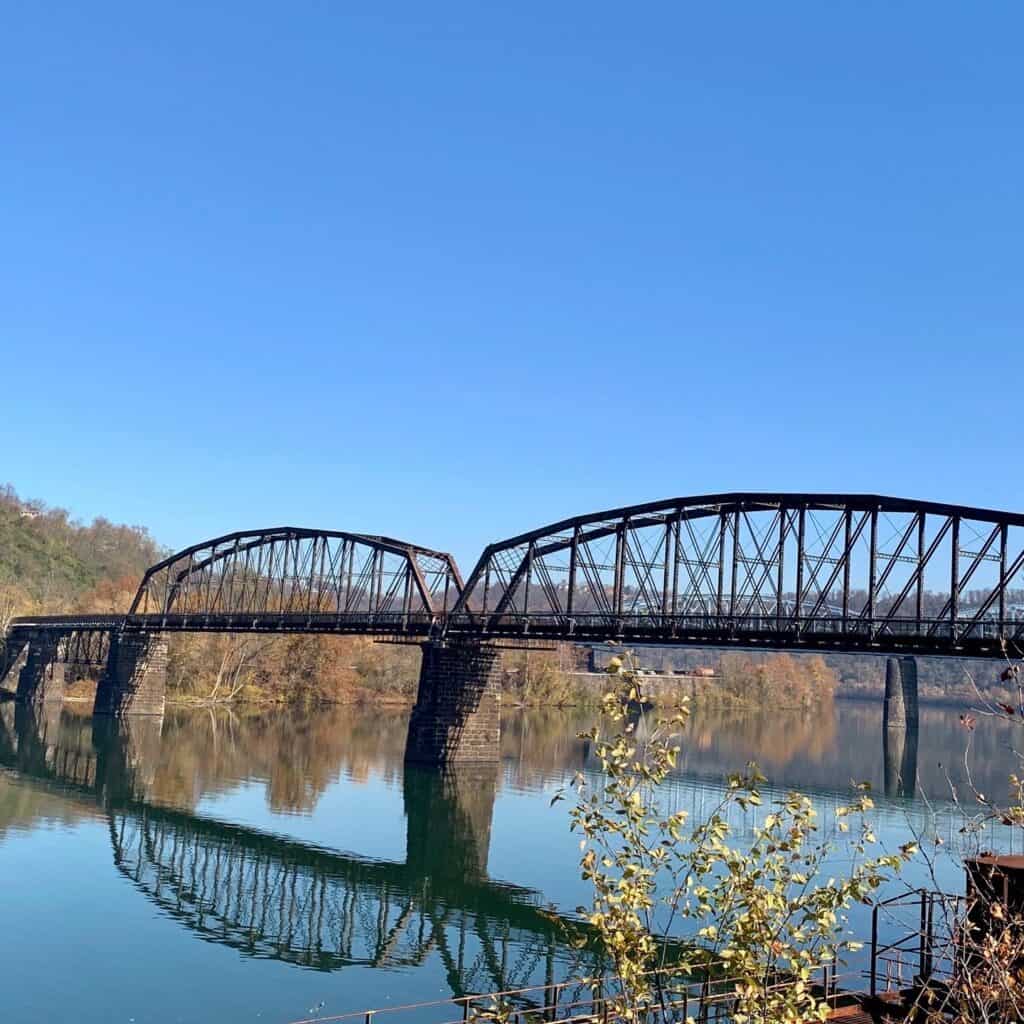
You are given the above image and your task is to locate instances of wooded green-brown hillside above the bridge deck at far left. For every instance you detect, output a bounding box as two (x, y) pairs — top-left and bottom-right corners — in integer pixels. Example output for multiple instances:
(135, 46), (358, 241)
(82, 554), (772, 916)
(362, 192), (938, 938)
(0, 484), (163, 614)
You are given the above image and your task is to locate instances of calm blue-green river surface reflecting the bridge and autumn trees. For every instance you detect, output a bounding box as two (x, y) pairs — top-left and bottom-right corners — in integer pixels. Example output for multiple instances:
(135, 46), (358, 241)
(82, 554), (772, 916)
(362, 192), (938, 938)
(0, 702), (1015, 1024)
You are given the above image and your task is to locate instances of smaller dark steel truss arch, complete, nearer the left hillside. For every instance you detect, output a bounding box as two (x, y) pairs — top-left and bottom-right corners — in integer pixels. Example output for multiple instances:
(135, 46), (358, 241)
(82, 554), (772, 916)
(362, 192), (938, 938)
(127, 526), (462, 632)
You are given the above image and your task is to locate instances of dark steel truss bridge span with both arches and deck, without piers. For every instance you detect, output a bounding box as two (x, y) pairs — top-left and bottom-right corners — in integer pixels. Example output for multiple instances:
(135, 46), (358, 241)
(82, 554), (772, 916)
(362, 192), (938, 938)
(6, 493), (1024, 659)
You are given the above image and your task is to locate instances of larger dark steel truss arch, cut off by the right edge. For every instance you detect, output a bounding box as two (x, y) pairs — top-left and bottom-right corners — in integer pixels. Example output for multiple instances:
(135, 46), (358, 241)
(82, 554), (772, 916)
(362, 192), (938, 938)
(446, 493), (1024, 655)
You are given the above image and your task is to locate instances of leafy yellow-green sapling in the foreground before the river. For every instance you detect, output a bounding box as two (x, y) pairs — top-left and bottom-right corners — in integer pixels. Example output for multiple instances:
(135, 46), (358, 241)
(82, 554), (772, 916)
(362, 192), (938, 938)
(555, 658), (914, 1024)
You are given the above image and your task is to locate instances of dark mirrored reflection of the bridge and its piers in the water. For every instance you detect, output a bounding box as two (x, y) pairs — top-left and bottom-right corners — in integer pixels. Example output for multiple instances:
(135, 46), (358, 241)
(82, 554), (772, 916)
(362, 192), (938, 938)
(0, 703), (593, 995)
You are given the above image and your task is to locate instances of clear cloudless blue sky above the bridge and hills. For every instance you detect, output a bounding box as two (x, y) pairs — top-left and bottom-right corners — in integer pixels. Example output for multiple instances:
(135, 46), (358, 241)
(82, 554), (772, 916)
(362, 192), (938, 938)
(0, 0), (1024, 563)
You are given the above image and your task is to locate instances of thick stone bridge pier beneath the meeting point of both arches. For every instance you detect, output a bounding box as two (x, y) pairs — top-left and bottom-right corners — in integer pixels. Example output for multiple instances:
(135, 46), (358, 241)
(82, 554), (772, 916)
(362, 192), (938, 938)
(406, 640), (502, 765)
